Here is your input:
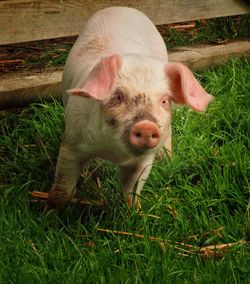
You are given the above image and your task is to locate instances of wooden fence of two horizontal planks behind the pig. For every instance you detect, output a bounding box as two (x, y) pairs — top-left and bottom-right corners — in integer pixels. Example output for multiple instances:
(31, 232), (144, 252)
(0, 0), (250, 109)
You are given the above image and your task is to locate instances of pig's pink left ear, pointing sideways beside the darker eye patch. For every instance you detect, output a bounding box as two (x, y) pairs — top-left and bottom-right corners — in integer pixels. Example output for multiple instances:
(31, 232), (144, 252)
(67, 55), (122, 101)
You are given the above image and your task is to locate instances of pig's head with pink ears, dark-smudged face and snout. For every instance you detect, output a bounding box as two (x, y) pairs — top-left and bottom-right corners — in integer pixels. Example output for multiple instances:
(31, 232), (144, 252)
(68, 54), (213, 156)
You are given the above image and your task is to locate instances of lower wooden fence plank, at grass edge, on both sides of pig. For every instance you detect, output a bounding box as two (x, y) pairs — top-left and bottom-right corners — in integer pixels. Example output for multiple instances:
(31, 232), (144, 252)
(0, 41), (250, 109)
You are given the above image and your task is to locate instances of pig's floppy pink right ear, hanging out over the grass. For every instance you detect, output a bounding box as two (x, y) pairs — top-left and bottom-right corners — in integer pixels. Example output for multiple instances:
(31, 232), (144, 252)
(165, 63), (213, 112)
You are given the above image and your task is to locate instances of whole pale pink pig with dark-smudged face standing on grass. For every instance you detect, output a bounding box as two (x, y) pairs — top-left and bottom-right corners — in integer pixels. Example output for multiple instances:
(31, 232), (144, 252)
(48, 7), (213, 210)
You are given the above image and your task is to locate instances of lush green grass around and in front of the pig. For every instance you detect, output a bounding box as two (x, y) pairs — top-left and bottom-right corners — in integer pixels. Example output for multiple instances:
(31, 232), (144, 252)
(0, 58), (250, 283)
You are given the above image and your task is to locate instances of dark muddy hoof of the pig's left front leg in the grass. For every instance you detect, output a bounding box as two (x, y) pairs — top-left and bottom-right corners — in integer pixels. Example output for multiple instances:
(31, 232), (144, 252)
(45, 187), (70, 212)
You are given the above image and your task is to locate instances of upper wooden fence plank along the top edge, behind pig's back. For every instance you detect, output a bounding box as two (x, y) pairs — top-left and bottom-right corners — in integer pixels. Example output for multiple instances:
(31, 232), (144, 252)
(0, 0), (250, 45)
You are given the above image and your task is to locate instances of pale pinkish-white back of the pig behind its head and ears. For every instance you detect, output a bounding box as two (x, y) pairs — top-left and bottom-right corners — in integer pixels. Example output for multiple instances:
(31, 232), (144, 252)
(63, 7), (167, 103)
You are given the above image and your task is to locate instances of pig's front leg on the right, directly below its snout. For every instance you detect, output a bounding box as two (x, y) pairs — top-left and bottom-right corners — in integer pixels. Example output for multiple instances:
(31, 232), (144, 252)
(120, 156), (154, 210)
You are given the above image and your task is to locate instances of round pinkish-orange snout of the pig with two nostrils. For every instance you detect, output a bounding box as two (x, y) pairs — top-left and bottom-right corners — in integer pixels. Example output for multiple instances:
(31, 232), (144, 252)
(129, 120), (161, 149)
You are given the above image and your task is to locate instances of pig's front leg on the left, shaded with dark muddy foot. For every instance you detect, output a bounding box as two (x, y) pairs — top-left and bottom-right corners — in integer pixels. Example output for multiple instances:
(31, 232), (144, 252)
(47, 142), (81, 210)
